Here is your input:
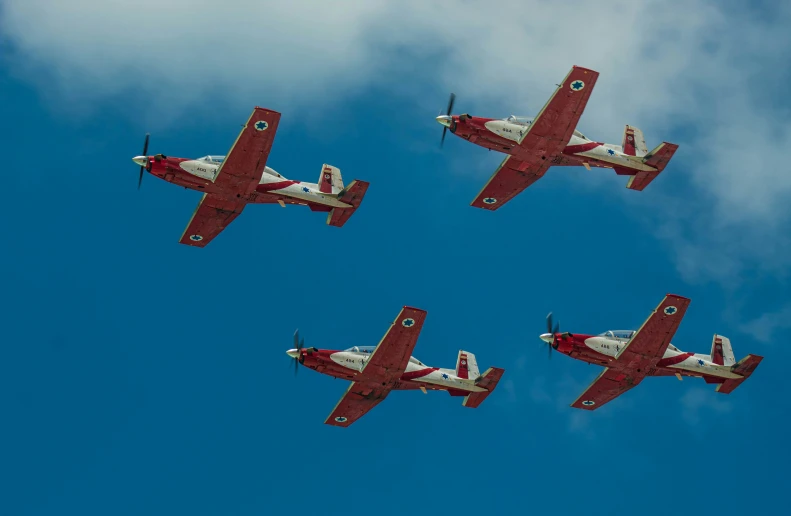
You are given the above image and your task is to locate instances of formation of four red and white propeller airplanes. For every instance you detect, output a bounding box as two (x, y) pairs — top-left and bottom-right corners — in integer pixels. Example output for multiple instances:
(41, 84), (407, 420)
(127, 66), (763, 427)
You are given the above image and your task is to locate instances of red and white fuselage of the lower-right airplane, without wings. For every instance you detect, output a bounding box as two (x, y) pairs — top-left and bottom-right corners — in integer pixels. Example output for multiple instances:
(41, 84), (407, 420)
(541, 331), (742, 378)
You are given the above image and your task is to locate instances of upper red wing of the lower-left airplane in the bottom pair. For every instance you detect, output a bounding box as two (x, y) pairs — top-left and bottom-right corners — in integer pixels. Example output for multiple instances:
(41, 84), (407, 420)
(362, 306), (426, 383)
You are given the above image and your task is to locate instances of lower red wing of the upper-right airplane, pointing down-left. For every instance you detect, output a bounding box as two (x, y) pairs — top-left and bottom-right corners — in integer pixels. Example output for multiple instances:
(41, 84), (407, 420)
(470, 156), (549, 211)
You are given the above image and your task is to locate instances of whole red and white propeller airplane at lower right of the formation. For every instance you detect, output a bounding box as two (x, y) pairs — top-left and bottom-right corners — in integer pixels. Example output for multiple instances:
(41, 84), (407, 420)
(540, 294), (763, 410)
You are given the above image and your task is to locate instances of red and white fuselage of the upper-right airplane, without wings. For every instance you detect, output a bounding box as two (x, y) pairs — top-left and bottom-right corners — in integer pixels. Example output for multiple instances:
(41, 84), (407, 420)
(437, 115), (656, 174)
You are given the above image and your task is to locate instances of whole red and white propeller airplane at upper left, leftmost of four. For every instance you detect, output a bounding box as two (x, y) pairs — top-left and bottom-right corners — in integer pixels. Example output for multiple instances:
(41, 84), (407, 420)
(132, 107), (369, 247)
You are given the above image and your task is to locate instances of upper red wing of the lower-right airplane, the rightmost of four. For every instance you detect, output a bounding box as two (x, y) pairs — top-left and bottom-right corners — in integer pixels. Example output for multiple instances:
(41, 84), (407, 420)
(615, 294), (689, 362)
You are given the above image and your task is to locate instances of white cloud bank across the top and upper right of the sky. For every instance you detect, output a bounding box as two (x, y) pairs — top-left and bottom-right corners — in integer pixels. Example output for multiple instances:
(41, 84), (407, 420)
(0, 0), (791, 282)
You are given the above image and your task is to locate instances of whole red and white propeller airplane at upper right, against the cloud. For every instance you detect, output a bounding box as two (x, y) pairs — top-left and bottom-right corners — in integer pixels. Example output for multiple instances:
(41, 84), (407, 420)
(437, 66), (678, 211)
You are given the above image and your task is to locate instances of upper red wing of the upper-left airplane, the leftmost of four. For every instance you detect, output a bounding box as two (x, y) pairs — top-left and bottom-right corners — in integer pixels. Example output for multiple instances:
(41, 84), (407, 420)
(214, 107), (280, 196)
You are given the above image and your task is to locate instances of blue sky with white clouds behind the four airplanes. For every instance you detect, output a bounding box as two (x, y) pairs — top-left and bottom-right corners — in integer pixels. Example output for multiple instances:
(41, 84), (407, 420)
(0, 0), (791, 515)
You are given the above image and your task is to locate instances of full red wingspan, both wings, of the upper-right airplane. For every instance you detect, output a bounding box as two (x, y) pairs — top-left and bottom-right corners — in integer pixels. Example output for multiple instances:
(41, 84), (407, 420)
(472, 66), (599, 211)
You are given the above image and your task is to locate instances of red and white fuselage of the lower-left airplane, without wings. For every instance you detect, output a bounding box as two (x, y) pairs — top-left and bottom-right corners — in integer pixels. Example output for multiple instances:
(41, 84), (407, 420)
(289, 347), (486, 396)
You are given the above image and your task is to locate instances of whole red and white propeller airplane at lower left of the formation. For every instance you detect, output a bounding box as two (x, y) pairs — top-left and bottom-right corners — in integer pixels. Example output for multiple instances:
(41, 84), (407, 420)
(286, 306), (505, 427)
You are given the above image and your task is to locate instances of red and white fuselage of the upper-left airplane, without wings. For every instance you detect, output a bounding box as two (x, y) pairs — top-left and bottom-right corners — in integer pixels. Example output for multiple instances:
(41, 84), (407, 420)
(134, 154), (351, 211)
